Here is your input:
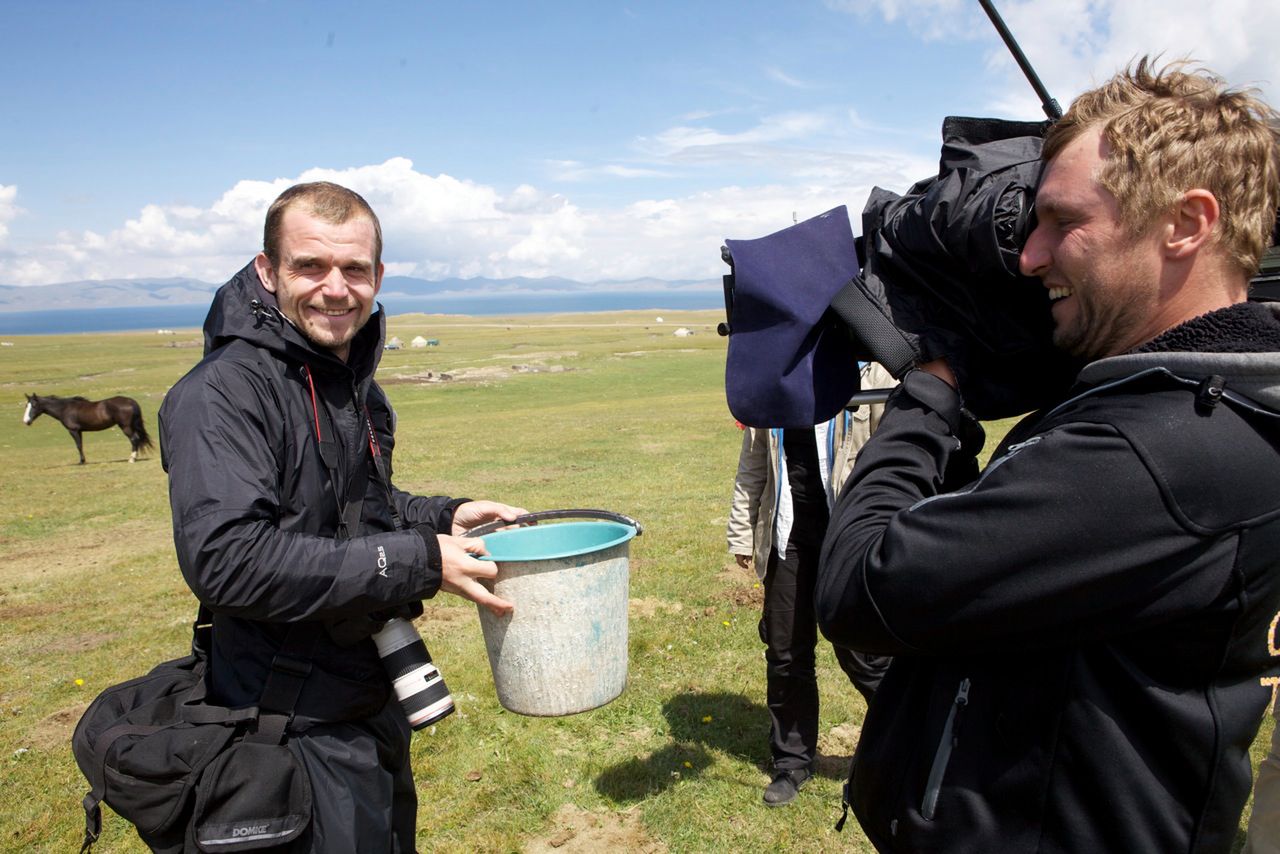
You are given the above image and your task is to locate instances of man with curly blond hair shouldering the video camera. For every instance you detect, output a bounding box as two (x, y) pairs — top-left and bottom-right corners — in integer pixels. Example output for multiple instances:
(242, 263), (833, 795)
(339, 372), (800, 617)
(817, 60), (1280, 853)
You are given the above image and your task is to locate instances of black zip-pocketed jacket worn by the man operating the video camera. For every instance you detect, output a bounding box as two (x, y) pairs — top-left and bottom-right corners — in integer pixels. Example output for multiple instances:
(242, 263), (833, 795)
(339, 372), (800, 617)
(817, 307), (1280, 854)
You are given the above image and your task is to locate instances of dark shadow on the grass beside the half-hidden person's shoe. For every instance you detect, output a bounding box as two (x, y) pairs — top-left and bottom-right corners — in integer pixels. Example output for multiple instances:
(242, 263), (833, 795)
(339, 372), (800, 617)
(595, 691), (769, 803)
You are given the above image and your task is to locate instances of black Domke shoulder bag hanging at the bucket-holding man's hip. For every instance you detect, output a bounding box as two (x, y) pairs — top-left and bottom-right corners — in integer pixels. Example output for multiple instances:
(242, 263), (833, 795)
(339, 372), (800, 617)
(72, 606), (320, 854)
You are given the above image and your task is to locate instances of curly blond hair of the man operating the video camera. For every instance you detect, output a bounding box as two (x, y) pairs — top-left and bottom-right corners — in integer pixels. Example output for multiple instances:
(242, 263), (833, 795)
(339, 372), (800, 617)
(1041, 56), (1280, 275)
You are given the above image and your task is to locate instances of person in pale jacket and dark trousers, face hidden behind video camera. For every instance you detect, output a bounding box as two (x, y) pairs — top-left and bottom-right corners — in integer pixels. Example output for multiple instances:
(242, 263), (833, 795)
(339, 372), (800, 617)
(727, 362), (896, 807)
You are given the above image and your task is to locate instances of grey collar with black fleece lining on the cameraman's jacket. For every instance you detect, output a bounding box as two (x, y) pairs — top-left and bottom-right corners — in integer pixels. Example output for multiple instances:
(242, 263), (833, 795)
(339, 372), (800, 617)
(1079, 302), (1280, 412)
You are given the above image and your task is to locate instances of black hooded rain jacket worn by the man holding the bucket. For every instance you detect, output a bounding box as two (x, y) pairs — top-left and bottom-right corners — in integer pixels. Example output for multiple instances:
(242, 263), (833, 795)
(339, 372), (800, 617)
(160, 264), (465, 721)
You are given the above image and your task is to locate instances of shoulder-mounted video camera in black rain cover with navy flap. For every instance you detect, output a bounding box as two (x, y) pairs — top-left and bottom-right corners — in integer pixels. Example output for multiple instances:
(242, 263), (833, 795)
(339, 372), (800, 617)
(719, 0), (1280, 428)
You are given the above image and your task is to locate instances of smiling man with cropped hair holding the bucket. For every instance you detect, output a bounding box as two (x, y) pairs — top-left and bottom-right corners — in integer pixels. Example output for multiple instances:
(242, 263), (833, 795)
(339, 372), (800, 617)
(160, 182), (524, 853)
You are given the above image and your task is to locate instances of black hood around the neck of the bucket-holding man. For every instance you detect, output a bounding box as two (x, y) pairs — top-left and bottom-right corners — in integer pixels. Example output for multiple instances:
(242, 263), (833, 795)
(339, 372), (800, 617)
(204, 261), (387, 378)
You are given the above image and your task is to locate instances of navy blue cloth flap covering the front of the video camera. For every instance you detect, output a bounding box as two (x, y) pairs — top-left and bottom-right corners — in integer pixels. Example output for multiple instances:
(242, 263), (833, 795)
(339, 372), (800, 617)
(724, 205), (858, 428)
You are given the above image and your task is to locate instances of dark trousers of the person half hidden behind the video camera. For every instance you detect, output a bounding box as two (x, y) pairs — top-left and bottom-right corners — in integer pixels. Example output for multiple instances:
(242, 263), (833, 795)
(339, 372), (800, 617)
(760, 535), (892, 771)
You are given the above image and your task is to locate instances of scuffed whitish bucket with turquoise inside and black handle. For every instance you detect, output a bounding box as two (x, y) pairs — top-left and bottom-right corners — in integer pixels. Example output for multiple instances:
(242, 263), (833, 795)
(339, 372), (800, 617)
(467, 510), (641, 716)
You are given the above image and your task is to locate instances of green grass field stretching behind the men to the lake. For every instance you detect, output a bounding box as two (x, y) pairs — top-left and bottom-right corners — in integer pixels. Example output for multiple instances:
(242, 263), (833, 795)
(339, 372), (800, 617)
(0, 311), (1270, 853)
